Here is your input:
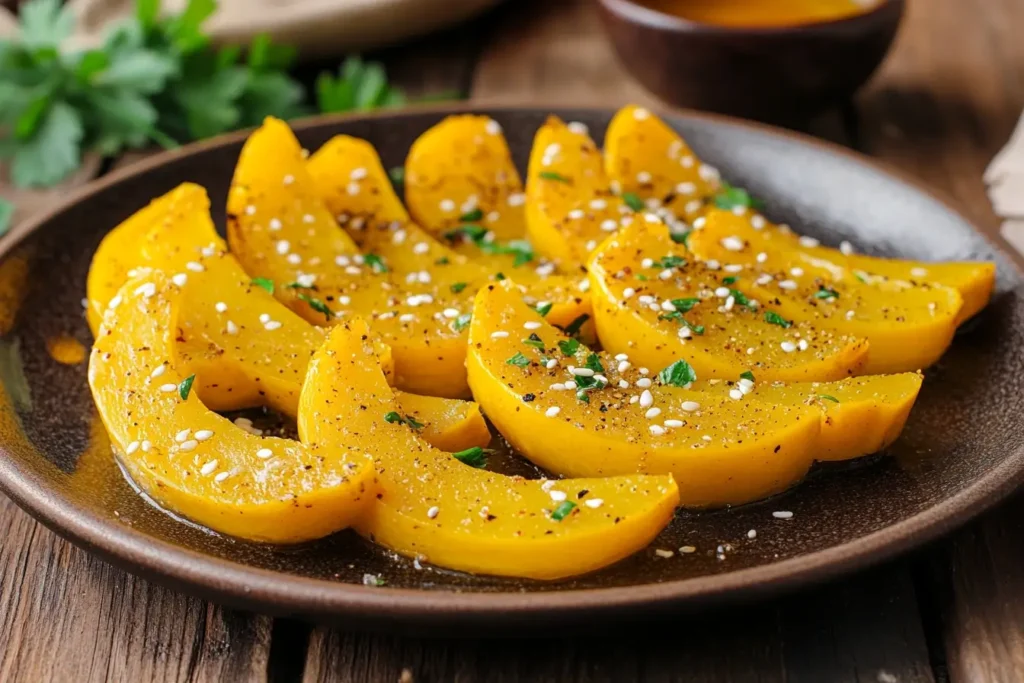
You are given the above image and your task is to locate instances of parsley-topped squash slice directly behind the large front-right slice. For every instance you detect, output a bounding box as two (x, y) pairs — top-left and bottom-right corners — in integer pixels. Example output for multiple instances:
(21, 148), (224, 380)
(590, 216), (868, 382)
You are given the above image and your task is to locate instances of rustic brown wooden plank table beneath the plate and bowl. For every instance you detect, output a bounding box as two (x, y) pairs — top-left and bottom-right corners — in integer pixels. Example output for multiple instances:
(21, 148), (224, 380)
(0, 0), (1024, 683)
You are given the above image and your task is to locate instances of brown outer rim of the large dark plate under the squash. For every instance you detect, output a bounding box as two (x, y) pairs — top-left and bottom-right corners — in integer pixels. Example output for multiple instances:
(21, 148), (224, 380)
(0, 100), (1024, 630)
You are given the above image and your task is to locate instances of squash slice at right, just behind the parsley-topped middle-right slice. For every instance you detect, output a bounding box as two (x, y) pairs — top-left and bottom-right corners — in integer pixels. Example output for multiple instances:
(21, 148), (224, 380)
(688, 209), (963, 375)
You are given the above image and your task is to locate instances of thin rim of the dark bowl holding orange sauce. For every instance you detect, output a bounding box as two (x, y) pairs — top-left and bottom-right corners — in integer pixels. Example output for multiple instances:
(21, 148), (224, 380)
(598, 0), (905, 37)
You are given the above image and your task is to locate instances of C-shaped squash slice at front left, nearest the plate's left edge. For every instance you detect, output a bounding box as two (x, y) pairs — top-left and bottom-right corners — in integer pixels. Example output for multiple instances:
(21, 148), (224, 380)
(89, 271), (376, 543)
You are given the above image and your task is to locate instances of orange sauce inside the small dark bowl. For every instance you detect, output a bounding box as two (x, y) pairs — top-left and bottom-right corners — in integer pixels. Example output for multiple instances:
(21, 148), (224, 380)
(639, 0), (882, 28)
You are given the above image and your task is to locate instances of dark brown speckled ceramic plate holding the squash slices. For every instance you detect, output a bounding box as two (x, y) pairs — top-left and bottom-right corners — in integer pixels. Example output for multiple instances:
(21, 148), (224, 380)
(0, 109), (1024, 630)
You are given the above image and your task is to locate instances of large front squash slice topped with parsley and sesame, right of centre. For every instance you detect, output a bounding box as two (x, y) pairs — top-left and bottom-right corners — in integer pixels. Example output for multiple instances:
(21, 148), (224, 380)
(467, 283), (820, 507)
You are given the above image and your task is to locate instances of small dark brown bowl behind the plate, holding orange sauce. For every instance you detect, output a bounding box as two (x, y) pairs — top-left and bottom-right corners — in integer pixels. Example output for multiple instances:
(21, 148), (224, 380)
(598, 0), (904, 122)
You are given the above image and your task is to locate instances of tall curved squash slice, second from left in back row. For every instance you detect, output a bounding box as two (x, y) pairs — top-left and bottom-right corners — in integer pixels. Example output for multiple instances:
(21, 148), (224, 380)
(227, 119), (472, 397)
